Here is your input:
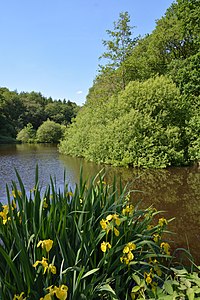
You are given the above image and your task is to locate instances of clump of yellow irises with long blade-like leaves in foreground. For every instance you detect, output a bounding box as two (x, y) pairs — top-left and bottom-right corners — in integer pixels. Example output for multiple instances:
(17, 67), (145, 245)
(0, 170), (200, 300)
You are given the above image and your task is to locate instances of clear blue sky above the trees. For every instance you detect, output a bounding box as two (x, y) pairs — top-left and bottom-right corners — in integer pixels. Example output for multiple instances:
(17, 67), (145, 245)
(0, 0), (173, 104)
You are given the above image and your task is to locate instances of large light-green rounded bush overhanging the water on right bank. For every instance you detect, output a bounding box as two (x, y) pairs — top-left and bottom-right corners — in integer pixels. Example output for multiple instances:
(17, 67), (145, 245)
(60, 76), (199, 168)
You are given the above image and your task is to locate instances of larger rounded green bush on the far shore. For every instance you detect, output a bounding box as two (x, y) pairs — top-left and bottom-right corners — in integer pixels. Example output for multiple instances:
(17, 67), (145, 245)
(36, 120), (63, 143)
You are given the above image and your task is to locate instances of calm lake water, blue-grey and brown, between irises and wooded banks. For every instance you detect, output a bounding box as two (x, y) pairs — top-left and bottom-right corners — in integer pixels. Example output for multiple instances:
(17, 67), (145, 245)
(0, 144), (200, 265)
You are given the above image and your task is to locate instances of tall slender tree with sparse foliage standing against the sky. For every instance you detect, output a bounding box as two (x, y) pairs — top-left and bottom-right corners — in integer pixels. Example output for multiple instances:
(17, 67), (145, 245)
(100, 12), (137, 89)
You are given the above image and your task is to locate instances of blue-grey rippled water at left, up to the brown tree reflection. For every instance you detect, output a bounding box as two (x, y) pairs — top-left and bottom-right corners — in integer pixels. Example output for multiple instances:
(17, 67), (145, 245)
(0, 144), (77, 199)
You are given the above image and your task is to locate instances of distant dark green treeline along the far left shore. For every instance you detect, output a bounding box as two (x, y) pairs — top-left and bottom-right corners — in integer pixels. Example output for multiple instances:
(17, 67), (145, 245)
(0, 87), (79, 142)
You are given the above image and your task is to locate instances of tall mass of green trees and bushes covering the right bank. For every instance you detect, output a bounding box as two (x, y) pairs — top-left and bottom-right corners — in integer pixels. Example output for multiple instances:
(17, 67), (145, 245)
(60, 0), (200, 167)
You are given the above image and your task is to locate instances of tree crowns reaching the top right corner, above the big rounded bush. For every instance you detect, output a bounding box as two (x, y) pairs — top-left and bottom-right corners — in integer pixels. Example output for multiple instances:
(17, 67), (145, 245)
(127, 0), (200, 80)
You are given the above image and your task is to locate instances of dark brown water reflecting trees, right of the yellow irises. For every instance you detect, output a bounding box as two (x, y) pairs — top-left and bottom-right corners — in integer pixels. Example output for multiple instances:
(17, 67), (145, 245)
(101, 167), (200, 264)
